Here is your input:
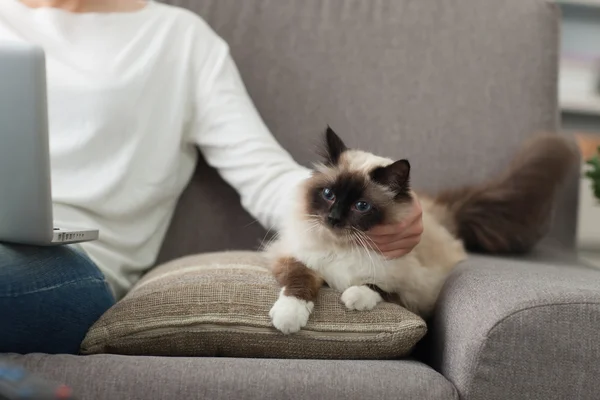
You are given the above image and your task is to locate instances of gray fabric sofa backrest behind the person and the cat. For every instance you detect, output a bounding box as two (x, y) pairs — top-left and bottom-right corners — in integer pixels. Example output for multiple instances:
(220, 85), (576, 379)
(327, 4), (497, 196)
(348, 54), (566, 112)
(159, 0), (577, 261)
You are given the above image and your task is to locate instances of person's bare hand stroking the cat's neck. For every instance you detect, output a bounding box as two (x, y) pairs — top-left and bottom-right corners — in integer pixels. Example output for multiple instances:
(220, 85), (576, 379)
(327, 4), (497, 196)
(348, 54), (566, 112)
(367, 198), (423, 258)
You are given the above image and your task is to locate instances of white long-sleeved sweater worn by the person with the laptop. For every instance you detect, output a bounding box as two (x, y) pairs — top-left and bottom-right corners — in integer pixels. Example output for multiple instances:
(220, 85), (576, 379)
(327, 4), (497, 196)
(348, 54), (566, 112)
(0, 0), (309, 297)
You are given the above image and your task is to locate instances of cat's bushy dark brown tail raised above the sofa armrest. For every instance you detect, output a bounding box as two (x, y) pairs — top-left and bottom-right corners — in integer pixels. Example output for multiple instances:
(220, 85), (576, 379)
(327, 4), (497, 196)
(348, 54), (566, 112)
(434, 135), (579, 254)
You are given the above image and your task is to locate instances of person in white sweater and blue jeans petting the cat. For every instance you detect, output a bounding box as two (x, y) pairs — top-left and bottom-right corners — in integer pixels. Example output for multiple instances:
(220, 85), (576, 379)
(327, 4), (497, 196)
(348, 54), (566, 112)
(0, 0), (422, 353)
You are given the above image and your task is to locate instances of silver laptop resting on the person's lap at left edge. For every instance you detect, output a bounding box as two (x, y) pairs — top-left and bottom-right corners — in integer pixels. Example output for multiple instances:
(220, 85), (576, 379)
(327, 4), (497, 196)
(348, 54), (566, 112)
(0, 42), (98, 245)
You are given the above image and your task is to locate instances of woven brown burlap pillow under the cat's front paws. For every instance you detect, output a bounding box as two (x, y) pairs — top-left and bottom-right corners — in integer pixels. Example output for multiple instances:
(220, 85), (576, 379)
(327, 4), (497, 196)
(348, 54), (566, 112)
(81, 252), (426, 359)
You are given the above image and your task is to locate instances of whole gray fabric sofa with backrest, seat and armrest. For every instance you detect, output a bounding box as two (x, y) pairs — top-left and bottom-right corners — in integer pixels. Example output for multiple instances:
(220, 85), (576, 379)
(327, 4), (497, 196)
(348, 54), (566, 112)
(8, 0), (600, 400)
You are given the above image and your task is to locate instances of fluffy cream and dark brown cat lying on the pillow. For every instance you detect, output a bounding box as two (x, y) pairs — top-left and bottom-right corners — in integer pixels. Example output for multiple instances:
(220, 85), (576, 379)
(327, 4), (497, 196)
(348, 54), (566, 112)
(264, 127), (578, 334)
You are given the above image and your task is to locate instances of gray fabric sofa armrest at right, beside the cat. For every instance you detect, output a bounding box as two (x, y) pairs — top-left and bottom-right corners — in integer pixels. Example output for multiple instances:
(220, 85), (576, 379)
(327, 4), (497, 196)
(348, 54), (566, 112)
(428, 250), (600, 400)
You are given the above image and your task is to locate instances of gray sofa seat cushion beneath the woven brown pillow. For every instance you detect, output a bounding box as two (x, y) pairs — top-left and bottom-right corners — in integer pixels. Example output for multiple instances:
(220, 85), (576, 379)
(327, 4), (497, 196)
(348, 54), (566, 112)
(11, 354), (458, 400)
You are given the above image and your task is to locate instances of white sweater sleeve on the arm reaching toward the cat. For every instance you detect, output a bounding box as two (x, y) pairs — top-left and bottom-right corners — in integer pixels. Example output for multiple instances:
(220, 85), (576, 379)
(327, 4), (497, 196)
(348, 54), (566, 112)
(192, 38), (310, 233)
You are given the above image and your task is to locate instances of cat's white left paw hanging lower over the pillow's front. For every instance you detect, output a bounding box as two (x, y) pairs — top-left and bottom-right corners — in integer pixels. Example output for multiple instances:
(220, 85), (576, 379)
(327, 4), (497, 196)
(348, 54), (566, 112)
(269, 293), (314, 335)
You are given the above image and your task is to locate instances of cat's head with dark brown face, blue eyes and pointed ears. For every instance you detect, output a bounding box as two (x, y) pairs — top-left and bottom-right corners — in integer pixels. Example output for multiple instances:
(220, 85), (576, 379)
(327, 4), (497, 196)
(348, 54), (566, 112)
(304, 127), (412, 237)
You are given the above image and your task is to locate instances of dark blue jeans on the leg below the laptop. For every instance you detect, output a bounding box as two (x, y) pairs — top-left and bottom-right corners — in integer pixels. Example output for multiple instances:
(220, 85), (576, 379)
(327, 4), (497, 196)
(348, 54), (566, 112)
(0, 243), (114, 354)
